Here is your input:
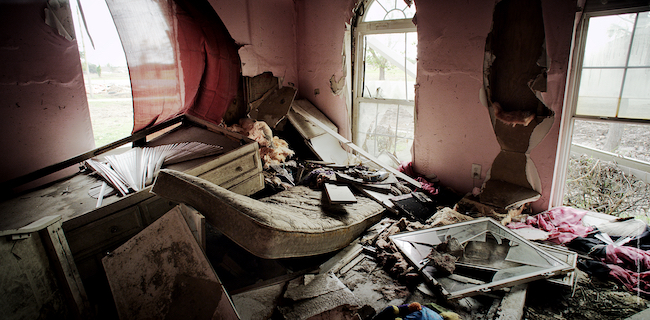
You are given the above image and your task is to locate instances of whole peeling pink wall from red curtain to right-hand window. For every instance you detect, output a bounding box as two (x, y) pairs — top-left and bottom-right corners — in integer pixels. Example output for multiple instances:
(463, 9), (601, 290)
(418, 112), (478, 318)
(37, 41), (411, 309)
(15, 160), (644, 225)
(210, 0), (576, 211)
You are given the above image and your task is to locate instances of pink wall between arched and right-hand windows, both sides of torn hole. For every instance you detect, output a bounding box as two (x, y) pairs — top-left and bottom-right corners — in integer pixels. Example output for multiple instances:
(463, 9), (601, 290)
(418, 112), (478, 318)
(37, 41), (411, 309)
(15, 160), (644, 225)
(414, 0), (575, 211)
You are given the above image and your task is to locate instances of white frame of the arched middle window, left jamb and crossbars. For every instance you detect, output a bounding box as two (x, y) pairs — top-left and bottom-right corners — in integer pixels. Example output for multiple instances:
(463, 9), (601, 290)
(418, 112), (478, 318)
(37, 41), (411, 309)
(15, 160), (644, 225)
(351, 15), (417, 160)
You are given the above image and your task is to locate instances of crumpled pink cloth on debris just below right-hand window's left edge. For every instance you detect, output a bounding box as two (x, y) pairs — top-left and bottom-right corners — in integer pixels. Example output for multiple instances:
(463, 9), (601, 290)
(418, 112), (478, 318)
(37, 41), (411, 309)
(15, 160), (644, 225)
(507, 207), (593, 244)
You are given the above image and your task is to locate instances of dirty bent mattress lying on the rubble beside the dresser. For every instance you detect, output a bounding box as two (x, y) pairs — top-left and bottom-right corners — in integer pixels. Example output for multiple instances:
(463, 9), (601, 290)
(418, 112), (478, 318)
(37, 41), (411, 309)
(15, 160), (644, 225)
(152, 169), (384, 259)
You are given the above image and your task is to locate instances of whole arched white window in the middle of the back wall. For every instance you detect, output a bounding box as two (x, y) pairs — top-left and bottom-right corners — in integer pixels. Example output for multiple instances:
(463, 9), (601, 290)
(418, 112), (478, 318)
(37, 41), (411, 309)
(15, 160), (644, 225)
(353, 0), (417, 161)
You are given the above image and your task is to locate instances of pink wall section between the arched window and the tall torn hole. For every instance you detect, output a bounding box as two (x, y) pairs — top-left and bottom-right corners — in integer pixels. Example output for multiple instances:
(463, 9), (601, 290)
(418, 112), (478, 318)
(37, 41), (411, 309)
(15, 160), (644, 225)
(413, 0), (500, 199)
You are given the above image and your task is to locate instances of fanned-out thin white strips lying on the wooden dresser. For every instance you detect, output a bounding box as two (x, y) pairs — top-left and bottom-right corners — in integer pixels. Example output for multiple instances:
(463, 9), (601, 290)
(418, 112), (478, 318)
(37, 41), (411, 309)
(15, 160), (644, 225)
(86, 142), (223, 196)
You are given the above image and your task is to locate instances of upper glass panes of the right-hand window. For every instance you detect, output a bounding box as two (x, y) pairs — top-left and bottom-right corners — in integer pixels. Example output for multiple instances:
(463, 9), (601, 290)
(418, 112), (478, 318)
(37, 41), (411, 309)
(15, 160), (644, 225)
(576, 11), (650, 119)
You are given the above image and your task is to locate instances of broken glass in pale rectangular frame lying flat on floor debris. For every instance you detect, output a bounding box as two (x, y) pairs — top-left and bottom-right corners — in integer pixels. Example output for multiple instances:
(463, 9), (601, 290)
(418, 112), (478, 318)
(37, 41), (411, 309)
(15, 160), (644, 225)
(390, 218), (573, 299)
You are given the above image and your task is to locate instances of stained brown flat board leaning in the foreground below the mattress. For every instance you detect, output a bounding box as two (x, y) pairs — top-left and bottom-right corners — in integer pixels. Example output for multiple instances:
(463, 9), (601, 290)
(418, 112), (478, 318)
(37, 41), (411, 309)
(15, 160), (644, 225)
(102, 207), (239, 320)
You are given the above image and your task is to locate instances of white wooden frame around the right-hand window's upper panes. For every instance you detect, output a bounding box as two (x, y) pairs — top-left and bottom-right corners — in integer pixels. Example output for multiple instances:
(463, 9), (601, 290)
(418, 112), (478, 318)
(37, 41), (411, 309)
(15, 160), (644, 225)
(548, 6), (650, 209)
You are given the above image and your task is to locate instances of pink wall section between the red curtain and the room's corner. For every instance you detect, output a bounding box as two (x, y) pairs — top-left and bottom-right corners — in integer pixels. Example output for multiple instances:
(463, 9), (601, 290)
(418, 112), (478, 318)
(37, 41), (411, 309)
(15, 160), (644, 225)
(208, 0), (298, 88)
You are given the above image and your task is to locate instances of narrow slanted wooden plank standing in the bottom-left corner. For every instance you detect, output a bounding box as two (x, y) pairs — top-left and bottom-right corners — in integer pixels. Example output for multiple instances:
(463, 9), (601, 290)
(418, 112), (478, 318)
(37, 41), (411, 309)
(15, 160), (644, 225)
(39, 221), (90, 319)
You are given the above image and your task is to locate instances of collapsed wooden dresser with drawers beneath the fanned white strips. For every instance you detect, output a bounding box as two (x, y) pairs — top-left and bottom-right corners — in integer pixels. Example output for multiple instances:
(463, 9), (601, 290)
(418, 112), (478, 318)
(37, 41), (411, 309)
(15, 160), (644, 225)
(0, 115), (264, 318)
